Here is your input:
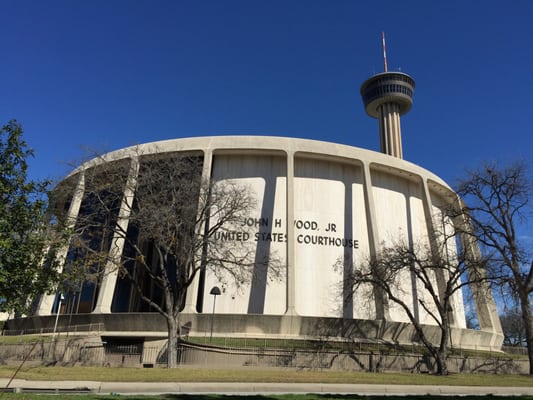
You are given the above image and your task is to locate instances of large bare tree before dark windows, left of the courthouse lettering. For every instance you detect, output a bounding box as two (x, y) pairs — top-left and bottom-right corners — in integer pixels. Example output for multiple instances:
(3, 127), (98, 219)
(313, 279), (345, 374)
(60, 153), (269, 368)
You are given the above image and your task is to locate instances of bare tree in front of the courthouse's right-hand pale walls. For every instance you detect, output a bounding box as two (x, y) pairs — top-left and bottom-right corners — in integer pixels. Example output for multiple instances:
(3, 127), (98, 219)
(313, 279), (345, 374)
(348, 225), (486, 375)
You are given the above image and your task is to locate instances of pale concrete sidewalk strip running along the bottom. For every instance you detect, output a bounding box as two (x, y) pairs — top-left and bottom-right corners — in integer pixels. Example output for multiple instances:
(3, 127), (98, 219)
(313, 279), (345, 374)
(0, 379), (533, 396)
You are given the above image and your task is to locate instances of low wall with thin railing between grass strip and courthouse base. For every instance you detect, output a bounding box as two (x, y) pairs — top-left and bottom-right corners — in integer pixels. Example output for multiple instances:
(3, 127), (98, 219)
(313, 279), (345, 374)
(0, 338), (528, 373)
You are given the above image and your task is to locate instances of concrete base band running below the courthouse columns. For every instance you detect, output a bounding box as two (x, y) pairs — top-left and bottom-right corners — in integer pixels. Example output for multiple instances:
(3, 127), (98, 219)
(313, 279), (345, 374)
(5, 313), (501, 351)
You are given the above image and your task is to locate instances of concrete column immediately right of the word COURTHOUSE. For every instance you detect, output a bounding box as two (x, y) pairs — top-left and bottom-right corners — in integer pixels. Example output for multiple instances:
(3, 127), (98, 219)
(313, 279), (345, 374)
(363, 163), (390, 320)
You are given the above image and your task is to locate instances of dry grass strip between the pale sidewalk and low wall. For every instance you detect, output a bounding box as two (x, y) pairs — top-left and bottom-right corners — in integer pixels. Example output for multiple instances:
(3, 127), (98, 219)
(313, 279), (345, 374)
(0, 366), (533, 386)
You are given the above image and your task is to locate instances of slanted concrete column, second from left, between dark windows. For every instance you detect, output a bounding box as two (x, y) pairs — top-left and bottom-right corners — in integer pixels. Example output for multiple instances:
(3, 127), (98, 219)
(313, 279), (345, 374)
(93, 157), (139, 314)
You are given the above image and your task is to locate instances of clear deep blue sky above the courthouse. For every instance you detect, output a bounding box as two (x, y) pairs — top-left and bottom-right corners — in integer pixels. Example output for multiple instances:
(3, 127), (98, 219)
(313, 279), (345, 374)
(0, 0), (533, 184)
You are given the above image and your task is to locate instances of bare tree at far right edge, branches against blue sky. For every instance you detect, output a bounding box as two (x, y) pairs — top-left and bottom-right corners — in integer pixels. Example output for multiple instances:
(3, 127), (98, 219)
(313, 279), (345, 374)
(457, 163), (533, 375)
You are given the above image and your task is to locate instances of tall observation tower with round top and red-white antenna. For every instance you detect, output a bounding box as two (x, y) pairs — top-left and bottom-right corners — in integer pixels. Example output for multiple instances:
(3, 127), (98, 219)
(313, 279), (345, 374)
(361, 33), (415, 158)
